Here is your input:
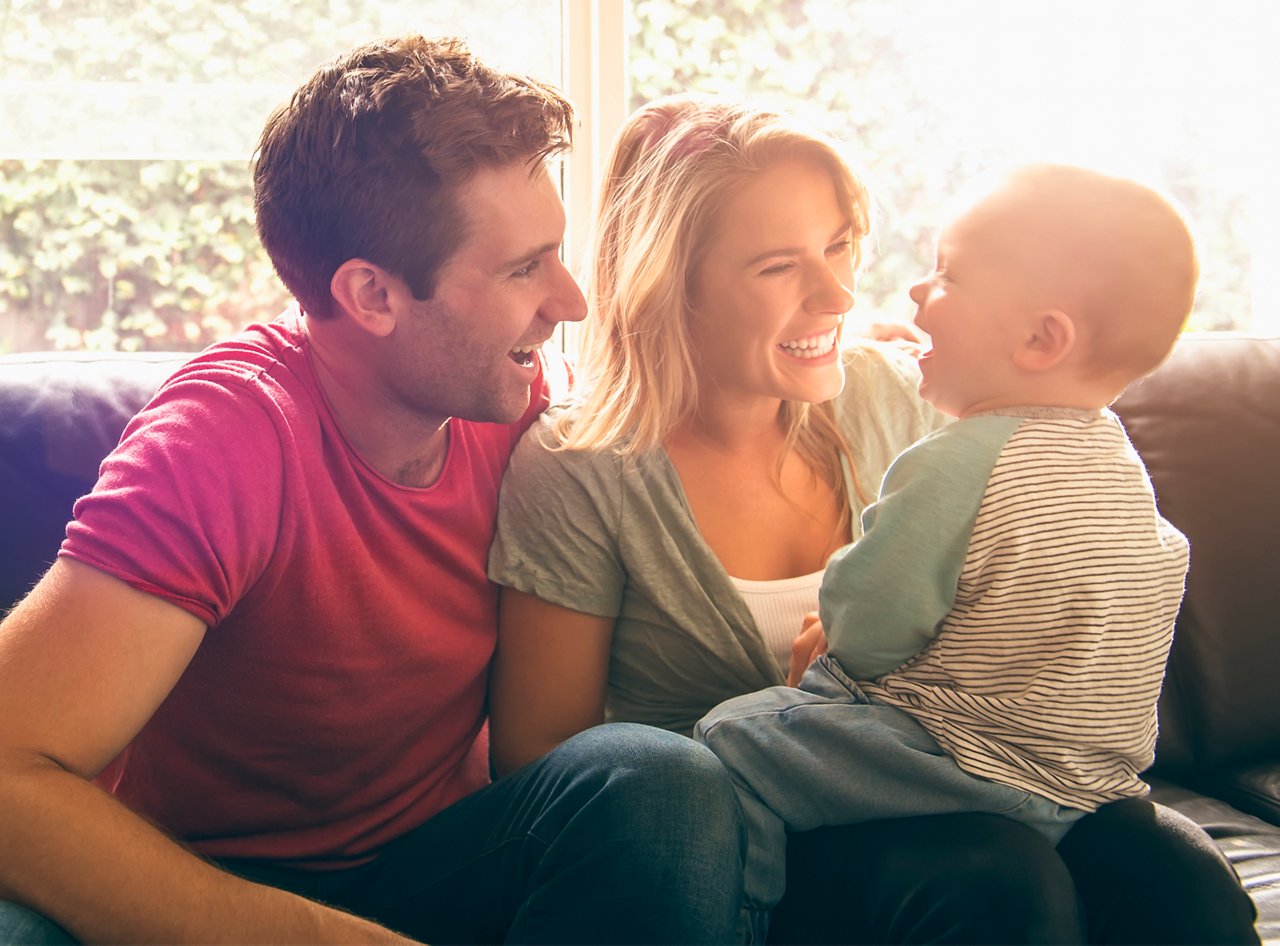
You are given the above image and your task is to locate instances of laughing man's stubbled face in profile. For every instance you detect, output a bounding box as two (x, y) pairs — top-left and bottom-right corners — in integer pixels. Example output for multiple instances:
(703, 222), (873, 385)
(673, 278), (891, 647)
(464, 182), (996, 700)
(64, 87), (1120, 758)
(388, 163), (586, 424)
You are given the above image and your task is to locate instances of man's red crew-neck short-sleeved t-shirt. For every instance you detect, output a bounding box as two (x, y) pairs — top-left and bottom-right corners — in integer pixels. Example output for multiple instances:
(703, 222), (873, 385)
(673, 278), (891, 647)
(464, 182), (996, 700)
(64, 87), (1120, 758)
(60, 314), (558, 869)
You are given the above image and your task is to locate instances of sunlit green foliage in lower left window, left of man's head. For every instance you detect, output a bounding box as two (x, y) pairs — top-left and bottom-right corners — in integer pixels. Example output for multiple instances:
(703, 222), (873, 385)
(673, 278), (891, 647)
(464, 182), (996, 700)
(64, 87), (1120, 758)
(0, 160), (276, 351)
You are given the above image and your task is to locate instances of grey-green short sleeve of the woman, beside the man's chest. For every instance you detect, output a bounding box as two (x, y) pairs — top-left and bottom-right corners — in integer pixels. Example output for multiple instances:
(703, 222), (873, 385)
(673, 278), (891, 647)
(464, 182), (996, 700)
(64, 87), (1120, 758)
(489, 411), (626, 617)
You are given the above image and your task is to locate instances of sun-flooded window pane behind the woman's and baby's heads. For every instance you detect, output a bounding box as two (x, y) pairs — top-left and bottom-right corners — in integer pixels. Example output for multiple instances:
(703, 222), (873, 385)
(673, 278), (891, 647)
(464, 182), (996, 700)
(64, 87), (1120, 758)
(628, 0), (1280, 333)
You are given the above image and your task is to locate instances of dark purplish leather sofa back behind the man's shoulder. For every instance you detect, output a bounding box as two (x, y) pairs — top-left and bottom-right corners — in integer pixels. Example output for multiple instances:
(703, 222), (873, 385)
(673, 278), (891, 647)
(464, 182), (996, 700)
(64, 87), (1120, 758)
(0, 352), (191, 613)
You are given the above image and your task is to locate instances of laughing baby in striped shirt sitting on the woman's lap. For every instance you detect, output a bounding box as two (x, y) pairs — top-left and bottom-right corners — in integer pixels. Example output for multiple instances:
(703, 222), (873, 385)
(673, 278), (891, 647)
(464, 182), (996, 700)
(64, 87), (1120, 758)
(695, 165), (1198, 934)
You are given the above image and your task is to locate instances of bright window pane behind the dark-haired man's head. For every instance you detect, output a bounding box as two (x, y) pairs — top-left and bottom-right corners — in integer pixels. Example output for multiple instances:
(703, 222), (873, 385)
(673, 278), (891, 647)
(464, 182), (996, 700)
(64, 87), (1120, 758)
(0, 0), (562, 352)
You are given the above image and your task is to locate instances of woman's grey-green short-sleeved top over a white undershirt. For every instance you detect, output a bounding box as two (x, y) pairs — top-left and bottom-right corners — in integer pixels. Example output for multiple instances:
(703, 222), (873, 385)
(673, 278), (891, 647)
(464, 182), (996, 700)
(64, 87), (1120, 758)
(489, 343), (945, 735)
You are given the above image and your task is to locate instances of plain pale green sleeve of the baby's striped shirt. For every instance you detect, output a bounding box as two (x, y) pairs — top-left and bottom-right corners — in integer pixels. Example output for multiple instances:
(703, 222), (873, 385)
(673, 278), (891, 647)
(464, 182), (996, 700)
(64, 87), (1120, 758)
(819, 415), (1021, 680)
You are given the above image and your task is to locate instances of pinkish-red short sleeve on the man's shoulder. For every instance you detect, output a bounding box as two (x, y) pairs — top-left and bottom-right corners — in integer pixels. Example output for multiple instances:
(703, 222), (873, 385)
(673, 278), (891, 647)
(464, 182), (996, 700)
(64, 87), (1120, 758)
(61, 376), (283, 626)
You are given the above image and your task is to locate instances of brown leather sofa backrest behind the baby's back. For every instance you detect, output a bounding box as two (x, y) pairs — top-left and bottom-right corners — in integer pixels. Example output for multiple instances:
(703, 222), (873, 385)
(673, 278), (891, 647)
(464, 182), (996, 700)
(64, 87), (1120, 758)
(1116, 335), (1280, 771)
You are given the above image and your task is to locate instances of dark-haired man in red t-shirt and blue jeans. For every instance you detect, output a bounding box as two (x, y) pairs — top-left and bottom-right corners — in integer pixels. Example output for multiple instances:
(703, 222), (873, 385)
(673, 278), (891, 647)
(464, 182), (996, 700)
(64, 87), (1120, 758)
(0, 37), (742, 942)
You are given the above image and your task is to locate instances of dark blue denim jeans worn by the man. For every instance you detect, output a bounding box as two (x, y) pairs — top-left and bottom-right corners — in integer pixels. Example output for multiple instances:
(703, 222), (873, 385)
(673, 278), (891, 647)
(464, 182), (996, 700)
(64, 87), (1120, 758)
(0, 723), (745, 943)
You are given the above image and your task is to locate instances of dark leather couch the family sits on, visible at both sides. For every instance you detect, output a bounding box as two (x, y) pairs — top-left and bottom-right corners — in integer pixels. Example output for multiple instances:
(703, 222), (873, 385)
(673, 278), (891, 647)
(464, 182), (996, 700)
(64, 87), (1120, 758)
(0, 337), (1280, 942)
